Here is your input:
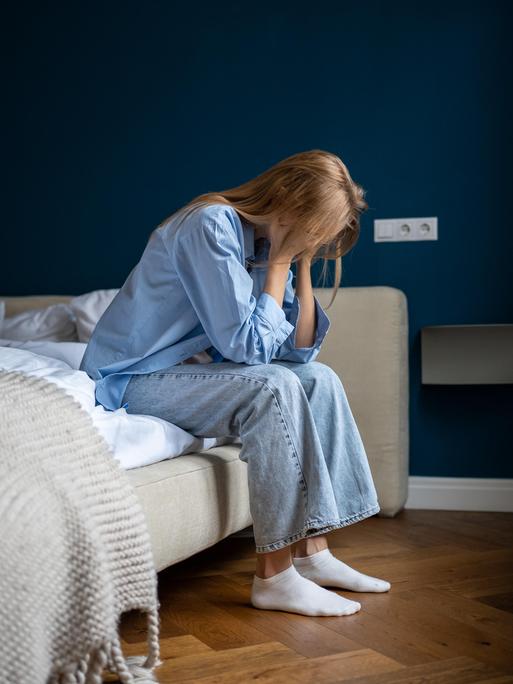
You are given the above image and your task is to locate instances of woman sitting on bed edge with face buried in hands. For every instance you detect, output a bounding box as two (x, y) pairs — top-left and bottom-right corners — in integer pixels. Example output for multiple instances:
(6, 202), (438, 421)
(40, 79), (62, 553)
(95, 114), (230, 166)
(81, 150), (390, 615)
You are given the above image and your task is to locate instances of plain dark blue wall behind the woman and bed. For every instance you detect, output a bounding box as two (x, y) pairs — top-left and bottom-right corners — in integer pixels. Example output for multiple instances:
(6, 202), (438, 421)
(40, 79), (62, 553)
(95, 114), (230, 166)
(0, 0), (513, 477)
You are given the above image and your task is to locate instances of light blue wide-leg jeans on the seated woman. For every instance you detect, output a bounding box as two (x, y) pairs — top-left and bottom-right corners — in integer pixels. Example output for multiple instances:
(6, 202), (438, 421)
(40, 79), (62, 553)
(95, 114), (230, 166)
(122, 359), (380, 553)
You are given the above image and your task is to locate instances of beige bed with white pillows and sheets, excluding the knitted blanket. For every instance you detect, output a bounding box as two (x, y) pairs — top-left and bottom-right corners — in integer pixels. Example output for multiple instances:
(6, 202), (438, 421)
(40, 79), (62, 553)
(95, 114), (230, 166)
(0, 286), (409, 570)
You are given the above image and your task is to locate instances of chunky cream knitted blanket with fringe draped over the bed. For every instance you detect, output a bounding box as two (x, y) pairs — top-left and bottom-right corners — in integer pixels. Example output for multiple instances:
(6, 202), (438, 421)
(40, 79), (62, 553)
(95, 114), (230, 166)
(0, 371), (159, 684)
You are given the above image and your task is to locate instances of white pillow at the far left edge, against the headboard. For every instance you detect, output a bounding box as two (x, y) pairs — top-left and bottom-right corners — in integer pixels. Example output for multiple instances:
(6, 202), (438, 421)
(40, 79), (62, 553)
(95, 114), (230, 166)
(0, 303), (78, 342)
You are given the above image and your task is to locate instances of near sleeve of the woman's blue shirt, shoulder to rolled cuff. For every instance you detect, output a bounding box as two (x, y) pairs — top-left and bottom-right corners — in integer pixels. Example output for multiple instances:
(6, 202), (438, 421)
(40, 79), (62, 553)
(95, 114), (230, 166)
(169, 217), (294, 364)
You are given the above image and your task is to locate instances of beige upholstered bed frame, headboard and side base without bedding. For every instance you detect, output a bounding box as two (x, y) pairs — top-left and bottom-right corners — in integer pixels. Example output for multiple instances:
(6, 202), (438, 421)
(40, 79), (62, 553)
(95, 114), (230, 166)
(0, 286), (409, 570)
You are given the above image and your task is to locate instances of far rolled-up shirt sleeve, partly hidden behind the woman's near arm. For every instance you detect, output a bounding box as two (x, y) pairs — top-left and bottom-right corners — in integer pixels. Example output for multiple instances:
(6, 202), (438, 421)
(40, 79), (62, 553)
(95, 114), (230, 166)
(276, 270), (331, 363)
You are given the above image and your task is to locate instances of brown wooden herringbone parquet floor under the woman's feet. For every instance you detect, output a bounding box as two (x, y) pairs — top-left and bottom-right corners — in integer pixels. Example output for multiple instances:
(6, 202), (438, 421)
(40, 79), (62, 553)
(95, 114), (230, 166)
(116, 509), (513, 684)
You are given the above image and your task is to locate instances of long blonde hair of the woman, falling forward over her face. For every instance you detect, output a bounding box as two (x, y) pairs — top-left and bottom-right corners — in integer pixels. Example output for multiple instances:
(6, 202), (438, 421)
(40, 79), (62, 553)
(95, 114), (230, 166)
(159, 150), (368, 308)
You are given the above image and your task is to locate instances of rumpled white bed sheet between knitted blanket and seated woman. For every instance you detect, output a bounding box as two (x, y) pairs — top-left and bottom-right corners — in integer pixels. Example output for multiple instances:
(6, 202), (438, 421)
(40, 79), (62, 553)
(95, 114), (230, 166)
(0, 339), (240, 470)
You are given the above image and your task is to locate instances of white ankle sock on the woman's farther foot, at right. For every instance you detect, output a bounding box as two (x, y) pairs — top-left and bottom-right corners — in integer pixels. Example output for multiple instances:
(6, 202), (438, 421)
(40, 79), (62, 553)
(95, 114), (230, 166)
(292, 549), (390, 591)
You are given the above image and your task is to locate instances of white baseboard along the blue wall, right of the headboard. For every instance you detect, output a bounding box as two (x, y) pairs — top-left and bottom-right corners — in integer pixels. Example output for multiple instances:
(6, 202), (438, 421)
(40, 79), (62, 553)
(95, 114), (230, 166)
(405, 475), (513, 513)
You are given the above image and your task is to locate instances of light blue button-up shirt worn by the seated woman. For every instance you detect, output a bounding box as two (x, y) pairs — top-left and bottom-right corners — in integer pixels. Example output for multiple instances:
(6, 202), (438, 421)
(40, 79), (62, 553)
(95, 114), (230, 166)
(80, 204), (330, 411)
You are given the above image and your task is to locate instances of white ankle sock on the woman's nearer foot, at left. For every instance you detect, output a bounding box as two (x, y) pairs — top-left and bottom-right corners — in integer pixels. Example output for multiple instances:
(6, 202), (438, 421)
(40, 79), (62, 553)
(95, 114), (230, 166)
(251, 565), (361, 615)
